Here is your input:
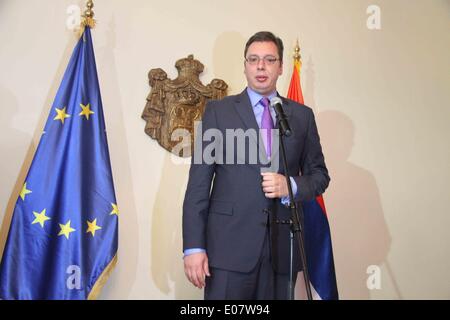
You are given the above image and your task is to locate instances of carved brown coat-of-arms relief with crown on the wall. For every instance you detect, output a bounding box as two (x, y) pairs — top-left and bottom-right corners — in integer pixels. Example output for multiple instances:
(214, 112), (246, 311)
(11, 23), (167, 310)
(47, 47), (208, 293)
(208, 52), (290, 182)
(142, 55), (228, 157)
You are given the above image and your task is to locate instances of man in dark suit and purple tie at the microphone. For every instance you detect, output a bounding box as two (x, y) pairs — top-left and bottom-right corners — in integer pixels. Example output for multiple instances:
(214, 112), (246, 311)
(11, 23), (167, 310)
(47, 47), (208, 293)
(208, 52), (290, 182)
(183, 32), (330, 299)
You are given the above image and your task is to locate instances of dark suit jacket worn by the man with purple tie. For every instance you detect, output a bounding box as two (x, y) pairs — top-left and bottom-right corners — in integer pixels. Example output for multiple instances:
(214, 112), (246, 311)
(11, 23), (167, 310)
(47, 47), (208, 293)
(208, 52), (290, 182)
(183, 90), (330, 273)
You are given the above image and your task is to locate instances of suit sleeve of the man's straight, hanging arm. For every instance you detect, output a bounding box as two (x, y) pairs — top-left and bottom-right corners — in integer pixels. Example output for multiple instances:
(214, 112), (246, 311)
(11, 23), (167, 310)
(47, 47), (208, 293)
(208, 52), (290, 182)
(183, 102), (217, 251)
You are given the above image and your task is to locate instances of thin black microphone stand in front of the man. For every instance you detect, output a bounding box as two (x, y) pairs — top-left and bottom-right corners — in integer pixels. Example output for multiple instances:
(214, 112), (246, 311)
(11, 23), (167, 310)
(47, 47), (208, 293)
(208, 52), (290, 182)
(276, 119), (312, 300)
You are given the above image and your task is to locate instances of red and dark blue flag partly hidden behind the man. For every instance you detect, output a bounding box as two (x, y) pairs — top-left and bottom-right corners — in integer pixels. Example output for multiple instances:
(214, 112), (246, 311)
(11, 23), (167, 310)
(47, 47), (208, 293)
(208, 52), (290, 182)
(287, 55), (339, 300)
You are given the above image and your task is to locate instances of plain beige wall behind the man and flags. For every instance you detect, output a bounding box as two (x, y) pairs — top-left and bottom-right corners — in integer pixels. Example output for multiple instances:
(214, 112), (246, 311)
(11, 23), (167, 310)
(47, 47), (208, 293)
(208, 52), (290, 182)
(0, 0), (450, 299)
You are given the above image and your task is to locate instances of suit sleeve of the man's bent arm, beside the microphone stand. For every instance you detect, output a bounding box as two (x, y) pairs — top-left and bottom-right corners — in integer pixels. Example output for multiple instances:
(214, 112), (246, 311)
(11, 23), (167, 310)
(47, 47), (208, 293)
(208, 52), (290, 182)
(294, 108), (330, 201)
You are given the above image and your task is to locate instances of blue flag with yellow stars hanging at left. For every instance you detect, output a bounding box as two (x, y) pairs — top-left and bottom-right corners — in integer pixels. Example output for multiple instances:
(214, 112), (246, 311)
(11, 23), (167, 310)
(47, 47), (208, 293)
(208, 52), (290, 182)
(0, 27), (119, 299)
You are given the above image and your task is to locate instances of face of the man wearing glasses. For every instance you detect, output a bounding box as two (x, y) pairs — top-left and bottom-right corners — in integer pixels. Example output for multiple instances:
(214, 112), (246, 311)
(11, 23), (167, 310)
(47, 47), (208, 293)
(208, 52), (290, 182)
(244, 42), (283, 95)
